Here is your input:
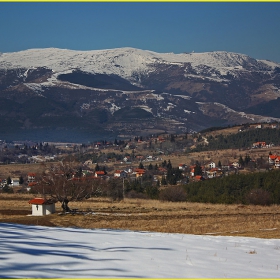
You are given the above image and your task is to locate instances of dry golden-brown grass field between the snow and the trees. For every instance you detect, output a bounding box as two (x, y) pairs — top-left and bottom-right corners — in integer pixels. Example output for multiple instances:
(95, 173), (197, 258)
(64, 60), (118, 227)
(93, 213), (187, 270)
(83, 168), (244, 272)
(0, 194), (280, 238)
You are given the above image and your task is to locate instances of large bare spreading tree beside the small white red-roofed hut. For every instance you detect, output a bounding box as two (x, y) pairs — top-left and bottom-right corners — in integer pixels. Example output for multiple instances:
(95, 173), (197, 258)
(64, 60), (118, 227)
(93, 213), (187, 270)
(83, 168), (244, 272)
(37, 162), (99, 212)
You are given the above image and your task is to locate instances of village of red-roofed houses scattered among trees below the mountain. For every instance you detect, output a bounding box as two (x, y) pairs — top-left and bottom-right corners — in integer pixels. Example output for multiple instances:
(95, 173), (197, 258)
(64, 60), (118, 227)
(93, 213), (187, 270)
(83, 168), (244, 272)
(0, 122), (280, 193)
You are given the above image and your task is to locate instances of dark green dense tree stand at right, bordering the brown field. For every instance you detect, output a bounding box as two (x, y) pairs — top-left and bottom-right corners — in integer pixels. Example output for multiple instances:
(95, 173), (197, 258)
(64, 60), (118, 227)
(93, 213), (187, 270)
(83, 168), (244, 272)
(184, 170), (280, 205)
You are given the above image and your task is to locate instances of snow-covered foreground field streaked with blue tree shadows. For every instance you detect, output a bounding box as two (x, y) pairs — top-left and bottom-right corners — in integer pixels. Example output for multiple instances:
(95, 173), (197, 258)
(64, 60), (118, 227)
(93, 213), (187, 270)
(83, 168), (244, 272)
(0, 223), (280, 278)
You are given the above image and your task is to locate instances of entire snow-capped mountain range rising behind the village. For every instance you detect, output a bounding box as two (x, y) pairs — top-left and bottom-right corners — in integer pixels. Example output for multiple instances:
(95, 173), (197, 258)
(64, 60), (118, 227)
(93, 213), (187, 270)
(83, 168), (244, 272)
(0, 48), (280, 142)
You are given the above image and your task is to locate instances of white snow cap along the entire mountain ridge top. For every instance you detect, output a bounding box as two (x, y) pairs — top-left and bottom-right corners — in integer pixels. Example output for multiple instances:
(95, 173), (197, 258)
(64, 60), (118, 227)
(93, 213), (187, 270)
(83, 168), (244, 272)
(0, 48), (280, 78)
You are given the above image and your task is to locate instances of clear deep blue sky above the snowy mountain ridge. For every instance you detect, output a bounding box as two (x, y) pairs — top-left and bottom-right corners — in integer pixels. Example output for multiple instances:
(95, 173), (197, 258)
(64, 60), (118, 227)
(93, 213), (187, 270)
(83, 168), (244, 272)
(0, 2), (280, 62)
